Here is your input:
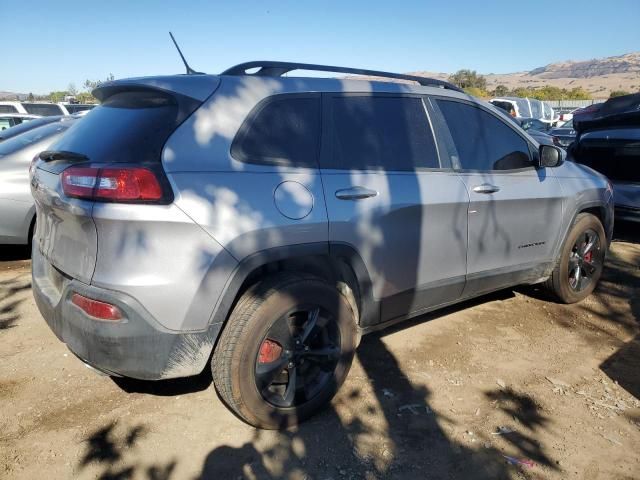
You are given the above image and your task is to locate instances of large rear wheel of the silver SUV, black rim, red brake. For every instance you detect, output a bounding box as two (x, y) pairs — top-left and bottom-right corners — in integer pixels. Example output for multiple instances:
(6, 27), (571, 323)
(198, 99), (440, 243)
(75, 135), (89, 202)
(211, 273), (356, 429)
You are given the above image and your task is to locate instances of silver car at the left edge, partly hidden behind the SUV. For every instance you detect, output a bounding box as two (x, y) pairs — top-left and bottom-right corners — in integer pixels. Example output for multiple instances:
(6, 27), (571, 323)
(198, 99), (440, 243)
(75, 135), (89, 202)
(0, 120), (73, 245)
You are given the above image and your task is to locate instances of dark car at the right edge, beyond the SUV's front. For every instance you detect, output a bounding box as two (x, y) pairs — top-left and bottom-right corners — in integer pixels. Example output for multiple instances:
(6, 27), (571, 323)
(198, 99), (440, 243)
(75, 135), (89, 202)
(570, 93), (640, 222)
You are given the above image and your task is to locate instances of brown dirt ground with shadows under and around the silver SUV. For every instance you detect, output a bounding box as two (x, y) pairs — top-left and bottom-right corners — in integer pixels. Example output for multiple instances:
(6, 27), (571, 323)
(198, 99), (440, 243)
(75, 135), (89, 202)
(0, 226), (640, 480)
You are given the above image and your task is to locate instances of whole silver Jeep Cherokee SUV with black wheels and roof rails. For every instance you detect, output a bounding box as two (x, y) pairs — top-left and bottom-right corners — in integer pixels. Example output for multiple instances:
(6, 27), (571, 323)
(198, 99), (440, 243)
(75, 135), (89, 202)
(31, 62), (613, 428)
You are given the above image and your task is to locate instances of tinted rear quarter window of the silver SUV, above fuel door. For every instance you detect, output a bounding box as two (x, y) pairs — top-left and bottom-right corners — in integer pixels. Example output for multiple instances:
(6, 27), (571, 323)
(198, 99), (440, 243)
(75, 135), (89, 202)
(231, 96), (320, 168)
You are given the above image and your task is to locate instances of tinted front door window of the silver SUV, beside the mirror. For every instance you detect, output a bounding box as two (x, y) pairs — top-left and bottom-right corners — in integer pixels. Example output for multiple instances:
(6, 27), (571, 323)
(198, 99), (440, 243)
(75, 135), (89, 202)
(437, 100), (532, 170)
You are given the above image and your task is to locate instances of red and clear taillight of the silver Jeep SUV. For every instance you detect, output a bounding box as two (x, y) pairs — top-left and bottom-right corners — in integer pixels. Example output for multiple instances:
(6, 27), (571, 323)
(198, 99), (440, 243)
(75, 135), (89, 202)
(62, 167), (163, 202)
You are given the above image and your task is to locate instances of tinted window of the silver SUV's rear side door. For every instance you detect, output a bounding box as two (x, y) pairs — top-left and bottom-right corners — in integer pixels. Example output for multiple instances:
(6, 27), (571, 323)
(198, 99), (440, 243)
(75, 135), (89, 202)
(323, 96), (439, 171)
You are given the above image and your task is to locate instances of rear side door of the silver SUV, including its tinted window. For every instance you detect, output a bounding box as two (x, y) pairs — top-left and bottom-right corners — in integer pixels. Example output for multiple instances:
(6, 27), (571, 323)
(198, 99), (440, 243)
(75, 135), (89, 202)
(320, 94), (468, 323)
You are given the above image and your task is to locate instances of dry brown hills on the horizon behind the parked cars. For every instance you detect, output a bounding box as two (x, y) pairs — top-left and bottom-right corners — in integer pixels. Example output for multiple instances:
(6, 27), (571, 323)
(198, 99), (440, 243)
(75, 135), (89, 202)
(413, 52), (640, 98)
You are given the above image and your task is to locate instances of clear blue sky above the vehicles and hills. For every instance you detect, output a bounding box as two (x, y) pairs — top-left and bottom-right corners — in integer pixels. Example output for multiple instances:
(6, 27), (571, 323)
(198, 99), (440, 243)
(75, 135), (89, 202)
(5, 0), (640, 93)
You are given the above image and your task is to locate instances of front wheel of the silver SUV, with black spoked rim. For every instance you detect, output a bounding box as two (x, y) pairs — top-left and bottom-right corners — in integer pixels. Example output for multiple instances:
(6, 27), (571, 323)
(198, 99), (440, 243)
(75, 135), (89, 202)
(545, 213), (607, 303)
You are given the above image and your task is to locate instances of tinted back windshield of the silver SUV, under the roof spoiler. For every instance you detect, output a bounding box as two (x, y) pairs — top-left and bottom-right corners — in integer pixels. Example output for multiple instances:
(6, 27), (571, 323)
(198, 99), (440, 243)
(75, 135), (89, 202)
(51, 91), (178, 163)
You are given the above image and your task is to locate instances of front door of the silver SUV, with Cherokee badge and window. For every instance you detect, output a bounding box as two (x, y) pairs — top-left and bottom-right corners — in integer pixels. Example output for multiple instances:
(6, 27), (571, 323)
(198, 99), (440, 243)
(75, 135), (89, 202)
(432, 98), (562, 296)
